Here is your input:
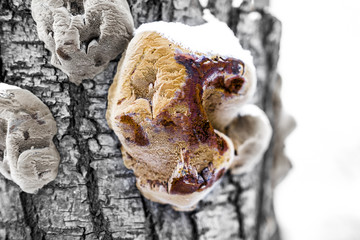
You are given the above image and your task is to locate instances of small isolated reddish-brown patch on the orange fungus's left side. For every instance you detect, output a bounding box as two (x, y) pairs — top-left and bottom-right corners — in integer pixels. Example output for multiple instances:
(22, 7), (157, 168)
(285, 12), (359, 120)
(115, 115), (149, 146)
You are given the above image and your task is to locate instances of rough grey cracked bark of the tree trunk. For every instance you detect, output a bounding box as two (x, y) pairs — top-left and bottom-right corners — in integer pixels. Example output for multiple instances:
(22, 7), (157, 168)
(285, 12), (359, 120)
(0, 0), (282, 240)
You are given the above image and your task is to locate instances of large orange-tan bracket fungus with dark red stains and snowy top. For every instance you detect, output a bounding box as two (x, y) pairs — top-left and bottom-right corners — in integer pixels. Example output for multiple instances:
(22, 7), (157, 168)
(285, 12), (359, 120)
(106, 21), (272, 211)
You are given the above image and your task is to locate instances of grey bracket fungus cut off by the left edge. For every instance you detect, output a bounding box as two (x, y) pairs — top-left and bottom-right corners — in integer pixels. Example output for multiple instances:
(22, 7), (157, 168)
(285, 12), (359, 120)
(0, 83), (60, 193)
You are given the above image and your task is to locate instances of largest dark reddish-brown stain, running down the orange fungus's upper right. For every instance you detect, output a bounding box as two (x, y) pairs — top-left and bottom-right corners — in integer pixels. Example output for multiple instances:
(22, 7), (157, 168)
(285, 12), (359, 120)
(154, 50), (245, 155)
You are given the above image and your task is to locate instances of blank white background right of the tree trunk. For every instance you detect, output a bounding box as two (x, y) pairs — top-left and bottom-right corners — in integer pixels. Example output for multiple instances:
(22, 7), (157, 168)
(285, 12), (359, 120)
(271, 0), (360, 240)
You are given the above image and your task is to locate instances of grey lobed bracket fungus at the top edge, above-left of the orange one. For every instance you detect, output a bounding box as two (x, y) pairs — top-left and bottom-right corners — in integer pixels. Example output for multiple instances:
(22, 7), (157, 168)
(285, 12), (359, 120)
(31, 0), (134, 84)
